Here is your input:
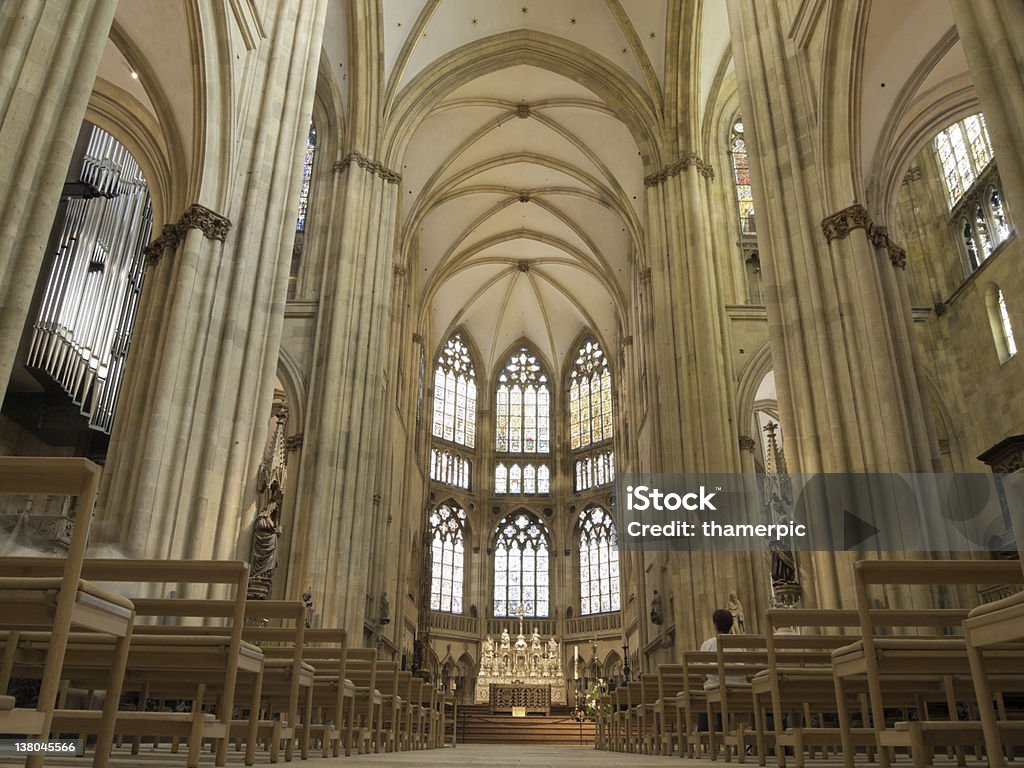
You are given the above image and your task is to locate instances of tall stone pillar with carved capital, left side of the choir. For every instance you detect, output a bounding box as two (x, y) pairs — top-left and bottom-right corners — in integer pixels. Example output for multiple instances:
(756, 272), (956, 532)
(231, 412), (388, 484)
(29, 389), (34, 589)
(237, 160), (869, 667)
(290, 152), (399, 644)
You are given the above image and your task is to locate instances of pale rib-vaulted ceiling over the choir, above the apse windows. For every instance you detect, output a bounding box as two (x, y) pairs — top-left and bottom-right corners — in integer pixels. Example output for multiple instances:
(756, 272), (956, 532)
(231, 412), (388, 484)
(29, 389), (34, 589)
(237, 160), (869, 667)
(399, 65), (644, 378)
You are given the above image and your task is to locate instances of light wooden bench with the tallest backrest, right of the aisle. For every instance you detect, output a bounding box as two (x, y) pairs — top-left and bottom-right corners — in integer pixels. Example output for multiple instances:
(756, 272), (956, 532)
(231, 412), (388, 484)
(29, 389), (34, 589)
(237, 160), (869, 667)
(833, 560), (1024, 768)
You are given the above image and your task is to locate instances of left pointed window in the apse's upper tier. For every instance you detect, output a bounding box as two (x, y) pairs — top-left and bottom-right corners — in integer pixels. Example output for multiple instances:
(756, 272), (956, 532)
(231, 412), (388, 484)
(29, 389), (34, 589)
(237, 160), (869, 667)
(433, 334), (476, 447)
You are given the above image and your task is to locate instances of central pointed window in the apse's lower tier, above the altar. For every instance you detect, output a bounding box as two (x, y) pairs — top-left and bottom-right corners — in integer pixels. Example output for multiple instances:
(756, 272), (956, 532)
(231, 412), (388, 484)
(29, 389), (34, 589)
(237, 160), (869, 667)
(495, 512), (550, 616)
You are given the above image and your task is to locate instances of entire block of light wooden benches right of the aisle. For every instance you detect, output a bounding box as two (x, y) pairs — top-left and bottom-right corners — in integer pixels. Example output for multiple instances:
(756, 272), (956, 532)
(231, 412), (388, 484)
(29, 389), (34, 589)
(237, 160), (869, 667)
(596, 560), (1024, 768)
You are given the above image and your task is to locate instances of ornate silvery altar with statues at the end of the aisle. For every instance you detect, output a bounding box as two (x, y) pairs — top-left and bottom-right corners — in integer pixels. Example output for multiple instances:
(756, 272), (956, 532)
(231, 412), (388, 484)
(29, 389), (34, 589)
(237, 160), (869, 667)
(474, 618), (567, 712)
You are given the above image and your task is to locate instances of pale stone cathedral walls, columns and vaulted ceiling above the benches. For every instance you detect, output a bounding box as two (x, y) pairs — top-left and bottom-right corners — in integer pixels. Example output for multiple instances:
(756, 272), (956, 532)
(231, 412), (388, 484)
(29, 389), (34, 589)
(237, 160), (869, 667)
(0, 0), (1024, 757)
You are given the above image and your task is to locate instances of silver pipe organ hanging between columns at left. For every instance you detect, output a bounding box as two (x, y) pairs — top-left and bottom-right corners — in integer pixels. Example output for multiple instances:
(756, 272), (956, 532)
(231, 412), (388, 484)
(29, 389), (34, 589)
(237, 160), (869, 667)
(28, 126), (153, 433)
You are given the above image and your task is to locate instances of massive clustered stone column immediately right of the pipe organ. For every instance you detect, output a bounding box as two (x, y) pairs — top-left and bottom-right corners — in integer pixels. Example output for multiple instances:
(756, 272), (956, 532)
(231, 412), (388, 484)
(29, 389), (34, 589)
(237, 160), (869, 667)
(98, 0), (326, 573)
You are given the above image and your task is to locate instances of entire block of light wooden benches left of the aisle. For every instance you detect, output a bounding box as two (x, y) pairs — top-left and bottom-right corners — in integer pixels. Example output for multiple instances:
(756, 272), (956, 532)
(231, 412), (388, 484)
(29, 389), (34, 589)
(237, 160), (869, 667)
(0, 458), (457, 768)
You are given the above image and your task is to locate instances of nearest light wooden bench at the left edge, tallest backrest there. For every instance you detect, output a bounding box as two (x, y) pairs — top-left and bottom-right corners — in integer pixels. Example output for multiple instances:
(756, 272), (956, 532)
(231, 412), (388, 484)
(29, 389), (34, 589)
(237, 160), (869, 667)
(0, 457), (135, 768)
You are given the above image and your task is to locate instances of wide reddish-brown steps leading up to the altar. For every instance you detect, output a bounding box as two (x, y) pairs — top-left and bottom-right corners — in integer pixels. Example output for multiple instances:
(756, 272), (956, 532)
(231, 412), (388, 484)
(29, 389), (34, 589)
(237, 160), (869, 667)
(459, 705), (594, 744)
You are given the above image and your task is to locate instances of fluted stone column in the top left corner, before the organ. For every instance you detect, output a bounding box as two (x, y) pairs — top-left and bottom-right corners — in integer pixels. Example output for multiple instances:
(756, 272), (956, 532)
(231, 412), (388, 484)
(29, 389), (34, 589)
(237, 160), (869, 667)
(0, 0), (118, 390)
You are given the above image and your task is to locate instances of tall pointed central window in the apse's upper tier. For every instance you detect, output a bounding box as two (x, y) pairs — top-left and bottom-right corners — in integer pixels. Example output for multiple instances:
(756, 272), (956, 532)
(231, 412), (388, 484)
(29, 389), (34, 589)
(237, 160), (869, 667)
(495, 347), (551, 454)
